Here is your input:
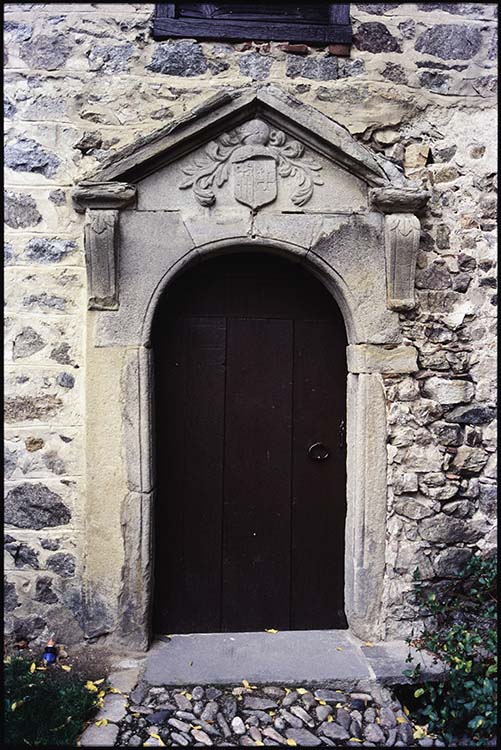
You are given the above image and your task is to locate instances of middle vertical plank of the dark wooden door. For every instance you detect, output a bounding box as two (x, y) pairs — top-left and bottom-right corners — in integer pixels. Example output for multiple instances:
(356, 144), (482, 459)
(222, 319), (292, 631)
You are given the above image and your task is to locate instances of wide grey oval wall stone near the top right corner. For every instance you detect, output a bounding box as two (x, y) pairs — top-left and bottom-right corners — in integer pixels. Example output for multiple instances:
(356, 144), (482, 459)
(415, 24), (482, 60)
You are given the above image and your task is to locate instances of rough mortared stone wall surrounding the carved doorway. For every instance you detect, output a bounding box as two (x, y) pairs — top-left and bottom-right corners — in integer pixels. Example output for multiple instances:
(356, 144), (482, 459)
(4, 3), (497, 641)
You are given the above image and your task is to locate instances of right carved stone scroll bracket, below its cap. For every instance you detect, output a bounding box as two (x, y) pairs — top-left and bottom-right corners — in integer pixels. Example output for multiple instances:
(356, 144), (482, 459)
(385, 214), (420, 310)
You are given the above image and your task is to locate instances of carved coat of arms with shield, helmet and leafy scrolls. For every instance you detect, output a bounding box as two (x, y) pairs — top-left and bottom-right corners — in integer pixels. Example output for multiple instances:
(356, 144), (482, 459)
(179, 119), (324, 210)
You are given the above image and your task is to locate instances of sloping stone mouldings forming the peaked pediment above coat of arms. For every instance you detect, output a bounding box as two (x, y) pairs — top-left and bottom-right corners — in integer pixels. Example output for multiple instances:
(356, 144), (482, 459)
(85, 85), (403, 187)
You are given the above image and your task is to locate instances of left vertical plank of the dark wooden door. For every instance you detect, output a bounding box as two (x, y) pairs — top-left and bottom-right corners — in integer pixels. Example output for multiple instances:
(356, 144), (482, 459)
(155, 318), (226, 633)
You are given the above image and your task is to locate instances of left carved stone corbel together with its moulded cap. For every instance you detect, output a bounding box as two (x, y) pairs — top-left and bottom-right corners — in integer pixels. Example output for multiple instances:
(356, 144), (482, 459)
(72, 182), (136, 310)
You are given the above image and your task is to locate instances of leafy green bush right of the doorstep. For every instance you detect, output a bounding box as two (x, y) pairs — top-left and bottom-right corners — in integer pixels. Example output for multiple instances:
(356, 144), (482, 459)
(401, 556), (497, 744)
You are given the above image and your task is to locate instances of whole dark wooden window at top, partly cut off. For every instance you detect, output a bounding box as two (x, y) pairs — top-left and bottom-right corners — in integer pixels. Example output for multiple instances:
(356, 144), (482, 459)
(153, 0), (352, 45)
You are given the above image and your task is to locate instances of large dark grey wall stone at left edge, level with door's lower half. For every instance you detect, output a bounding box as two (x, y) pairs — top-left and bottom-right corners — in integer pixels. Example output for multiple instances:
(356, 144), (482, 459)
(5, 482), (71, 529)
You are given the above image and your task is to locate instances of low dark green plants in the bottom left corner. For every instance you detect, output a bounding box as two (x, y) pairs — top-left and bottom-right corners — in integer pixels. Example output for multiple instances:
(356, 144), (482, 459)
(4, 657), (100, 747)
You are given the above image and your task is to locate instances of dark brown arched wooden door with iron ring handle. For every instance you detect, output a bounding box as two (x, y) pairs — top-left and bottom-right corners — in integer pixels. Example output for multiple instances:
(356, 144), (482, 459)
(153, 253), (346, 633)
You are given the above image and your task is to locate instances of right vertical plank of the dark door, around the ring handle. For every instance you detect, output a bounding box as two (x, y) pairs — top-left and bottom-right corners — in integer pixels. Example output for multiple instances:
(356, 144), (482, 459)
(291, 316), (346, 630)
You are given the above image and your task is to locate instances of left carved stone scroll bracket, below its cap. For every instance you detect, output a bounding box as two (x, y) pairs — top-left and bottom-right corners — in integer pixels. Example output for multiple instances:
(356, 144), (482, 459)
(85, 209), (118, 310)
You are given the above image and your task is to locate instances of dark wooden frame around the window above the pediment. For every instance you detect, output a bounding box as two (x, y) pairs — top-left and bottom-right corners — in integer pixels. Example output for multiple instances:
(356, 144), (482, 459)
(153, 0), (352, 46)
